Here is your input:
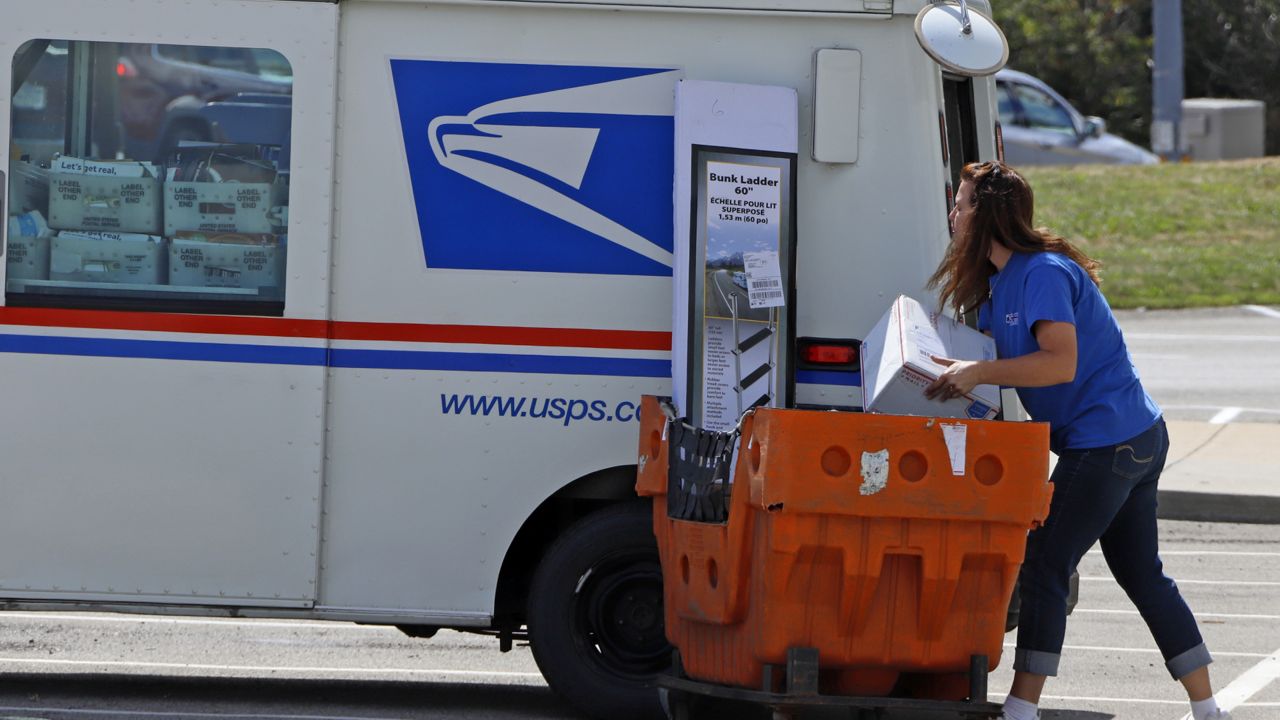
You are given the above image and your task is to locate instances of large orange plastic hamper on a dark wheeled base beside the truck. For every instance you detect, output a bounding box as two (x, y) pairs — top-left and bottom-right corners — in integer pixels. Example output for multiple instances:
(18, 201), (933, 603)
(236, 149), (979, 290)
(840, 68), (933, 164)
(636, 397), (1052, 700)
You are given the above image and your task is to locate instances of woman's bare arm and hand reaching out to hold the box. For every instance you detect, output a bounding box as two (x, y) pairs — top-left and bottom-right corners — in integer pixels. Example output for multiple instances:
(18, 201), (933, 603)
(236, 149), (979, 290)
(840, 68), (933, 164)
(924, 320), (1075, 400)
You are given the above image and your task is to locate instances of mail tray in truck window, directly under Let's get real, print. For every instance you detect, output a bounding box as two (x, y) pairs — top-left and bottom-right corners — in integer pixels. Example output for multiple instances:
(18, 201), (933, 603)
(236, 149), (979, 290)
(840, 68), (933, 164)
(49, 173), (160, 234)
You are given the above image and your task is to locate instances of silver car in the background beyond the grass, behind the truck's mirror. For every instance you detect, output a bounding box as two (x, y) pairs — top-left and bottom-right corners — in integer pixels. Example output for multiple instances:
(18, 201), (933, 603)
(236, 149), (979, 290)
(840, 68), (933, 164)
(996, 69), (1160, 165)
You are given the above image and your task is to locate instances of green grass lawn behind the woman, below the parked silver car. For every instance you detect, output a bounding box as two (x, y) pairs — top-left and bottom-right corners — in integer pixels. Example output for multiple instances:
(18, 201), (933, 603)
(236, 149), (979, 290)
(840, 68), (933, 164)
(1021, 158), (1280, 307)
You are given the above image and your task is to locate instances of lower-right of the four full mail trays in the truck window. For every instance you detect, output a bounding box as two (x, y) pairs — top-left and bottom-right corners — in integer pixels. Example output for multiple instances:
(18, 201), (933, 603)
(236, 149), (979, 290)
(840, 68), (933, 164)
(169, 237), (284, 288)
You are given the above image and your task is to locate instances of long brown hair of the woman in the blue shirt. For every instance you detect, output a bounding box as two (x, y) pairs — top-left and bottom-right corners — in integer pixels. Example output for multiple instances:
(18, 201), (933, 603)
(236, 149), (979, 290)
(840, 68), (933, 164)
(928, 160), (1102, 313)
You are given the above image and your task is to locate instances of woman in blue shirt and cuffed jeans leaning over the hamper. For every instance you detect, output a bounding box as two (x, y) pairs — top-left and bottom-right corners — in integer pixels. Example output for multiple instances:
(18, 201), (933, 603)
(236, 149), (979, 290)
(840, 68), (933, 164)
(925, 161), (1230, 720)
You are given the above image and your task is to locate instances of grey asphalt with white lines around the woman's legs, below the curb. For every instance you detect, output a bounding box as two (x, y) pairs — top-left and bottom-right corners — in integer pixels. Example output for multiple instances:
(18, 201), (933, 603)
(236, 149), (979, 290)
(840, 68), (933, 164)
(991, 521), (1280, 720)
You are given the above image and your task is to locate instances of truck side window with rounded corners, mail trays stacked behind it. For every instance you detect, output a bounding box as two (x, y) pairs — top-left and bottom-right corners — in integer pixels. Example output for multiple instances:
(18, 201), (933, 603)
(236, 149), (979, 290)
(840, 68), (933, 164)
(5, 40), (293, 315)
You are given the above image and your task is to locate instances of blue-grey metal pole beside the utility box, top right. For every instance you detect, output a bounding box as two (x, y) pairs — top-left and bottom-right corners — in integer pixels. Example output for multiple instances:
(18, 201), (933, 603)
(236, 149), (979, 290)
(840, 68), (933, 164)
(1151, 0), (1184, 160)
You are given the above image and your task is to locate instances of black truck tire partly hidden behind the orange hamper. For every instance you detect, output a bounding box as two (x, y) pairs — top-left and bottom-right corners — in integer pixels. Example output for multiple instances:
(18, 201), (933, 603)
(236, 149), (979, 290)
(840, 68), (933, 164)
(529, 502), (672, 720)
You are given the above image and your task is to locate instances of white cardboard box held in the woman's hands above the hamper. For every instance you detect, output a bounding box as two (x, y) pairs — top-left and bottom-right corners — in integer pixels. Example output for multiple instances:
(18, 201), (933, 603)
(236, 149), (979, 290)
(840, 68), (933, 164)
(861, 295), (1000, 420)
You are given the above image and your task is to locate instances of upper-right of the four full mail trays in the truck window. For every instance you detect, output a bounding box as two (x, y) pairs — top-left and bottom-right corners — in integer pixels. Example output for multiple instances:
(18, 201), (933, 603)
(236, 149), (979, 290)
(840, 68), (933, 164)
(164, 181), (279, 236)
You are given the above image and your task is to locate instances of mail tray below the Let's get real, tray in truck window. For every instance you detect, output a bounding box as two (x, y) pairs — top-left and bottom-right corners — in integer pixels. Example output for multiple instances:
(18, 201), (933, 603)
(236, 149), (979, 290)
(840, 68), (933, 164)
(49, 232), (168, 284)
